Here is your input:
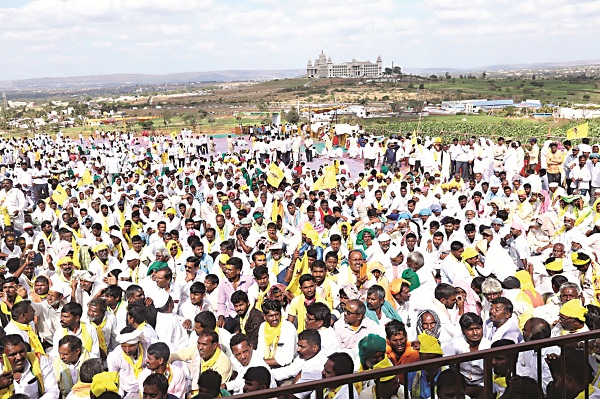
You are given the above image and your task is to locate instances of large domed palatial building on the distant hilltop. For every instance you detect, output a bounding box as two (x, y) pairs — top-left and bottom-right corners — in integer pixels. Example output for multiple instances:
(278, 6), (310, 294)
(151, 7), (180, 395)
(306, 51), (382, 78)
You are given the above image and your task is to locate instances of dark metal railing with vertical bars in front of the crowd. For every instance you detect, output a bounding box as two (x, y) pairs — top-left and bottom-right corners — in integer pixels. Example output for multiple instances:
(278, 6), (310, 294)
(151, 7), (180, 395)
(235, 330), (600, 399)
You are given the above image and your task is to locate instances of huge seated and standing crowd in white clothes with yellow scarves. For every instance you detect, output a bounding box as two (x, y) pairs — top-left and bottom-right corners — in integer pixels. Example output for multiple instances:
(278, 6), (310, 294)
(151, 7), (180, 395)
(0, 129), (600, 399)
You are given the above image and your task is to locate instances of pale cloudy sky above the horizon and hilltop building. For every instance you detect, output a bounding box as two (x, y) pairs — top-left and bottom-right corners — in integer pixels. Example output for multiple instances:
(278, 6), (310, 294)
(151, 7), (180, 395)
(0, 0), (600, 81)
